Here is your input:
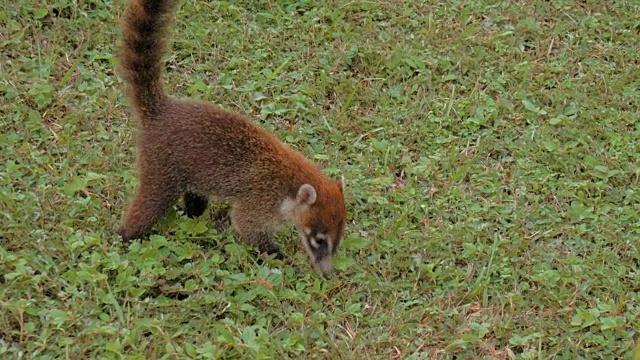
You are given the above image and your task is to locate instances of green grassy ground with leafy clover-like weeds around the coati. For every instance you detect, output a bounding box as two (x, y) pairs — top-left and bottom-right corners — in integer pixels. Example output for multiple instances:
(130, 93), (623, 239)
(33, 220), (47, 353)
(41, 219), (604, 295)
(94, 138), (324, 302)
(0, 0), (640, 359)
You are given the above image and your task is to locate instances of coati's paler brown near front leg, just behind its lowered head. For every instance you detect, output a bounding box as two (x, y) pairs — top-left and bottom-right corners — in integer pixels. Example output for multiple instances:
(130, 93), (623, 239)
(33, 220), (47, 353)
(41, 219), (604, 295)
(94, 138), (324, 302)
(231, 202), (280, 257)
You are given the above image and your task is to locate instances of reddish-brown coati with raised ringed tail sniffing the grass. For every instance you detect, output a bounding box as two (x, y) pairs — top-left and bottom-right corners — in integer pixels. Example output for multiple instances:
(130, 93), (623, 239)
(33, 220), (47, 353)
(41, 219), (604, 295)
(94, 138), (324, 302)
(118, 0), (346, 275)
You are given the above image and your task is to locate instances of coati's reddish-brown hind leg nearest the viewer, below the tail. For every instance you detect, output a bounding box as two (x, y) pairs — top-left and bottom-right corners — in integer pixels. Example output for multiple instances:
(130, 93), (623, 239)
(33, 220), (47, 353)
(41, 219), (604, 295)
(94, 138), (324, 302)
(118, 174), (181, 241)
